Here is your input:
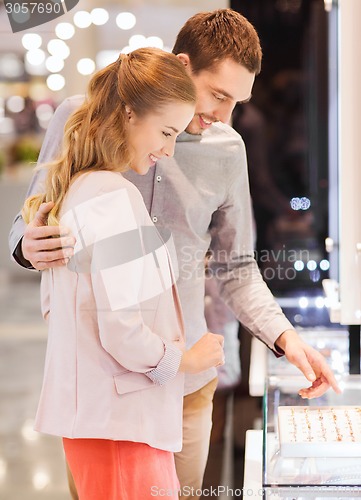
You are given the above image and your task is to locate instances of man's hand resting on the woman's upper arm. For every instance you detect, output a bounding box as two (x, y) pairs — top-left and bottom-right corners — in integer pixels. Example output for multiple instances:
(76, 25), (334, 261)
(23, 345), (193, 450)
(21, 202), (75, 271)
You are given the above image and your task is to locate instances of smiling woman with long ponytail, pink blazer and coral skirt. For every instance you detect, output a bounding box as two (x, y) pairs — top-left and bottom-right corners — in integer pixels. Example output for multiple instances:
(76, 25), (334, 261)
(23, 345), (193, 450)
(24, 49), (223, 500)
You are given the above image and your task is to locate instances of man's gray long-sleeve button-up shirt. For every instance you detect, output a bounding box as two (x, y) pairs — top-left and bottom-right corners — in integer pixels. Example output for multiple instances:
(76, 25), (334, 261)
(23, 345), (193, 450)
(9, 96), (293, 394)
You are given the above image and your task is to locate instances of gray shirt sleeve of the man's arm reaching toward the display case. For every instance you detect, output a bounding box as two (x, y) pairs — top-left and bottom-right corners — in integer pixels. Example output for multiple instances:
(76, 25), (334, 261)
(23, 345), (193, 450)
(209, 137), (293, 355)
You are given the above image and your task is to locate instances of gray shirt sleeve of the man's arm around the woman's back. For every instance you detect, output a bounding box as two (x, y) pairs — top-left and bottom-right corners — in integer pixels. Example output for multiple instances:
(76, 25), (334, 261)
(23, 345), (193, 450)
(9, 96), (84, 269)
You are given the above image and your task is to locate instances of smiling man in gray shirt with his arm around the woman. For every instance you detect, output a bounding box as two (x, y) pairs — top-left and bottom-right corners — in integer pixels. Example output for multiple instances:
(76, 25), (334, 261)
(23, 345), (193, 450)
(10, 9), (339, 498)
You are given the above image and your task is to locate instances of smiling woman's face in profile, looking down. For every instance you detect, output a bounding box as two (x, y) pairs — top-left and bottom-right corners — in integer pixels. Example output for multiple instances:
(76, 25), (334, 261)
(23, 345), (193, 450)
(126, 102), (195, 175)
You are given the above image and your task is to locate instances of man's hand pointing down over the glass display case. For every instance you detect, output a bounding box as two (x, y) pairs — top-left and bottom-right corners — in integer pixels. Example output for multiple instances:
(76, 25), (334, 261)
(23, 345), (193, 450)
(276, 330), (341, 399)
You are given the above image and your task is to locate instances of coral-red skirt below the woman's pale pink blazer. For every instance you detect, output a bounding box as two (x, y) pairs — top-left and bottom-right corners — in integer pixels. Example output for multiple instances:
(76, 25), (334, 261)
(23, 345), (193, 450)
(63, 438), (179, 500)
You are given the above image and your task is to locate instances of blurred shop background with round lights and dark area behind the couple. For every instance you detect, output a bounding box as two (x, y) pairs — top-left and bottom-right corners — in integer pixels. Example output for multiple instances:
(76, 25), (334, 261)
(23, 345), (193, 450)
(0, 0), (359, 500)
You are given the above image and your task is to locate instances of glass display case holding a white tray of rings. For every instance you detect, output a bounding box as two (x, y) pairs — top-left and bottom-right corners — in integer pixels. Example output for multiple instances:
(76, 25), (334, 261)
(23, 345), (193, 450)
(263, 375), (361, 500)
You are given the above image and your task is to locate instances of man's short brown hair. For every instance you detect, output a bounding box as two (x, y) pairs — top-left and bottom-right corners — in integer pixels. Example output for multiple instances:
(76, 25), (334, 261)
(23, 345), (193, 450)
(173, 9), (262, 75)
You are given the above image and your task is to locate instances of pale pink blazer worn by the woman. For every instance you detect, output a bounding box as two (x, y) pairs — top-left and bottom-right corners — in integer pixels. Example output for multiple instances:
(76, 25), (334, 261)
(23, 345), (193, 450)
(35, 171), (184, 451)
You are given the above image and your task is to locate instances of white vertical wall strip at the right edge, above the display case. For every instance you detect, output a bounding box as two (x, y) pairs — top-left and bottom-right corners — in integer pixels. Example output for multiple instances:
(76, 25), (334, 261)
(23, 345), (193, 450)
(338, 0), (361, 325)
